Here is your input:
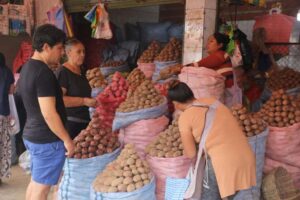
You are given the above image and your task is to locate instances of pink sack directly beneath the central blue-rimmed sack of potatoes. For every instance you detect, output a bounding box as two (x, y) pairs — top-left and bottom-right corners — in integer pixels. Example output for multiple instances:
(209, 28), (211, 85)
(120, 116), (169, 158)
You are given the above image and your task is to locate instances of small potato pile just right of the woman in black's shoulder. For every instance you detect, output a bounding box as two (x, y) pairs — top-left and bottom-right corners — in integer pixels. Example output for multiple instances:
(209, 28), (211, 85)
(86, 67), (107, 88)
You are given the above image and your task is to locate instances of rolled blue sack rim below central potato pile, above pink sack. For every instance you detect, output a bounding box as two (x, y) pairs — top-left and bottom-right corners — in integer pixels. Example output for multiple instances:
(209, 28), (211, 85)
(112, 97), (168, 131)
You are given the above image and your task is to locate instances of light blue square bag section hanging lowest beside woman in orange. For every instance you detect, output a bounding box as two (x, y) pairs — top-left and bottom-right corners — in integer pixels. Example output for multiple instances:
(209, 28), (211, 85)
(165, 177), (190, 200)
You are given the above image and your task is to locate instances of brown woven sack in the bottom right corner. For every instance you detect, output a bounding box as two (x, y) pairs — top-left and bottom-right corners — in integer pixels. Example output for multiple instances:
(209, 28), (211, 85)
(262, 167), (300, 200)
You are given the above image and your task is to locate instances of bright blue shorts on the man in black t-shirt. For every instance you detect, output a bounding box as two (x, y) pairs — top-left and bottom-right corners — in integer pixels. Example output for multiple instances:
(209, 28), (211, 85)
(24, 139), (66, 185)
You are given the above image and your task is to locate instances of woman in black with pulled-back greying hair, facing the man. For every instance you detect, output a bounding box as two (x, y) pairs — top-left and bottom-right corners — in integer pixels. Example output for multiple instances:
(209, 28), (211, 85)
(56, 38), (97, 139)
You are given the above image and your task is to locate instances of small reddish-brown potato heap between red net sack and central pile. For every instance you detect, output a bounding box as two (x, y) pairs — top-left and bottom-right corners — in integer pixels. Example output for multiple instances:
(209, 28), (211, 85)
(127, 68), (146, 97)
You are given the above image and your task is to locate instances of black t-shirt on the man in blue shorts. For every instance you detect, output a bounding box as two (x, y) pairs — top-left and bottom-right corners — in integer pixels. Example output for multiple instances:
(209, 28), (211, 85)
(18, 59), (66, 143)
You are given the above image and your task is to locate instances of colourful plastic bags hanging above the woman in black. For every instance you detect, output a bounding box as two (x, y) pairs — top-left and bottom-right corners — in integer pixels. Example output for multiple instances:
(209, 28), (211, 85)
(84, 3), (113, 40)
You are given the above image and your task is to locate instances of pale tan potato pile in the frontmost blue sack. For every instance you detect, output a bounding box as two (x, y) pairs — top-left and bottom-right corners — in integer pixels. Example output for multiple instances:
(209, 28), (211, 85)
(93, 144), (152, 193)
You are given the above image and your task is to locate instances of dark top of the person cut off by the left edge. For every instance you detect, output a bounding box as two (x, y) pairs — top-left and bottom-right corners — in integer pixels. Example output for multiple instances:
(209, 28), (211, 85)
(0, 67), (14, 116)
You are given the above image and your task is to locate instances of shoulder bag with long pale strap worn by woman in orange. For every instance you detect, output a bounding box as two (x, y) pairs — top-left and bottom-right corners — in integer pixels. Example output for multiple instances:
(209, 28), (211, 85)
(165, 101), (220, 200)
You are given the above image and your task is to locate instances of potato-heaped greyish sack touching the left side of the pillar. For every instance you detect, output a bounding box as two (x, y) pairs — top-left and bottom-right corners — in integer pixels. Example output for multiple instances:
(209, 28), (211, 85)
(152, 38), (182, 81)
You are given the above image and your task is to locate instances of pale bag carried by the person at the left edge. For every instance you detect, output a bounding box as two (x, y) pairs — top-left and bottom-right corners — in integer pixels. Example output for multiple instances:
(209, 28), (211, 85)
(8, 94), (20, 135)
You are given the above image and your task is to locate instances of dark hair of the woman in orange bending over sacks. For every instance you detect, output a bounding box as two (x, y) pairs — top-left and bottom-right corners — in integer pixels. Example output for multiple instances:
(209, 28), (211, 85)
(168, 81), (195, 103)
